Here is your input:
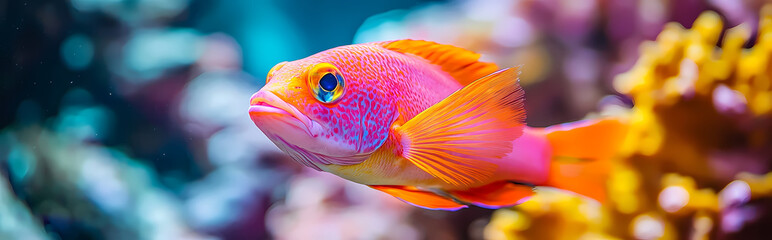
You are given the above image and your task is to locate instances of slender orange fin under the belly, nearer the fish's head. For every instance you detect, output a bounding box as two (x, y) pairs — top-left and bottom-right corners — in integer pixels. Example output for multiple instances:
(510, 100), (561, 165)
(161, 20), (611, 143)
(370, 185), (467, 211)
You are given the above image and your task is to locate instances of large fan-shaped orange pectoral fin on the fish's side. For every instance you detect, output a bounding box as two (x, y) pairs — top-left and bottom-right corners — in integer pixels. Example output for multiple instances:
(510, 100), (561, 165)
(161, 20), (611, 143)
(395, 68), (525, 186)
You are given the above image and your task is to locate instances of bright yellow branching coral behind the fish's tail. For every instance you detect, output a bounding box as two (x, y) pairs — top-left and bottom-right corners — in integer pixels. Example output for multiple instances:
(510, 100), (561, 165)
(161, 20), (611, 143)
(485, 6), (772, 239)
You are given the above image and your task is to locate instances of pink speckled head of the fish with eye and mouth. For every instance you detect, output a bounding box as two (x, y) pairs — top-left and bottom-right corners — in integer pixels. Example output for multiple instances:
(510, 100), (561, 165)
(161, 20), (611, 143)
(249, 45), (398, 170)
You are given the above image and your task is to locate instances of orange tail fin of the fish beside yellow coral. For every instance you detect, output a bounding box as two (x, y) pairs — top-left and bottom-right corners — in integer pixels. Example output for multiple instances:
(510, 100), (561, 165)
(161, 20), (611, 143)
(545, 118), (628, 202)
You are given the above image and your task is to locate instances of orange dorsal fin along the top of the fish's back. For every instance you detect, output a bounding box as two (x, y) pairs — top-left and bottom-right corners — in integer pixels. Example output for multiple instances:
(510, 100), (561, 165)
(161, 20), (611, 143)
(376, 39), (498, 86)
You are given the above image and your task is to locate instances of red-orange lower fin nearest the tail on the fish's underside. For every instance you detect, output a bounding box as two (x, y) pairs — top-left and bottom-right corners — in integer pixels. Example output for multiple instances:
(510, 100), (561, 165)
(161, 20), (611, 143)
(449, 181), (534, 209)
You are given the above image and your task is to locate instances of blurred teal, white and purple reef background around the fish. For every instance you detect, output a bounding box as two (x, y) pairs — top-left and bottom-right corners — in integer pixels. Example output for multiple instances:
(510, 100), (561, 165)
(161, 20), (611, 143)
(0, 0), (772, 239)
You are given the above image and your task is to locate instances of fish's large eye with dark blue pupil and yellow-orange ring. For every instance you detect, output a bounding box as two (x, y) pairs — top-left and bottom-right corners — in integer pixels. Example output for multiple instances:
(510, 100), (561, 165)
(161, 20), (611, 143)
(308, 63), (345, 103)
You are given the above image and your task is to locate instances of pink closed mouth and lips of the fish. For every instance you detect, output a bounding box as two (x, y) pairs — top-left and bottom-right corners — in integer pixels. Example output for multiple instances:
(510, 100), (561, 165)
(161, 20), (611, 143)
(249, 91), (321, 137)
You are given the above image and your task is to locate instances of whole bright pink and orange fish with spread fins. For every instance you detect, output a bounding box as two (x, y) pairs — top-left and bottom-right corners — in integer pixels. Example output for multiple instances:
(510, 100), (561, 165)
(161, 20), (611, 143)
(249, 39), (628, 211)
